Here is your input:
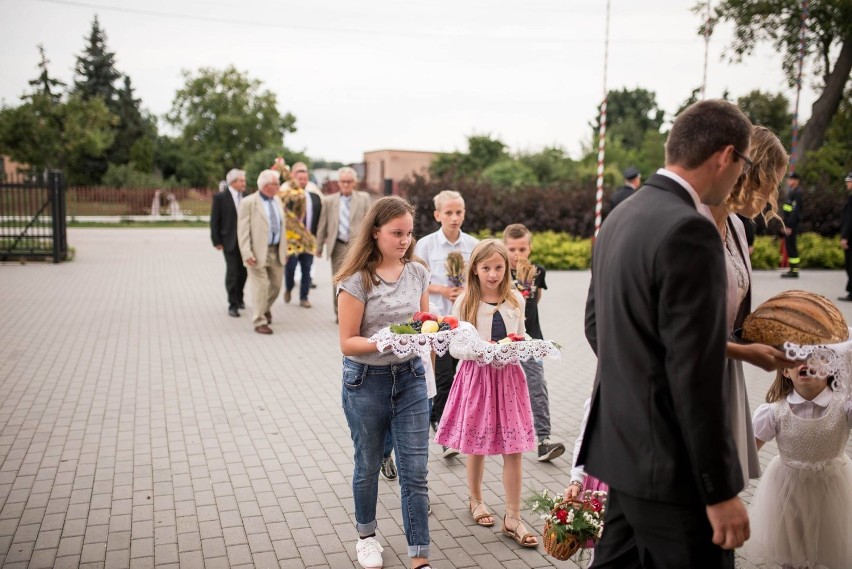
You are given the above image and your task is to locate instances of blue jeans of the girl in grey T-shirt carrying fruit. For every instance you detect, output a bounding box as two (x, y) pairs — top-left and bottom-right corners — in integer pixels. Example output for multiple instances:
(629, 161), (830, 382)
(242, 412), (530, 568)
(342, 357), (429, 557)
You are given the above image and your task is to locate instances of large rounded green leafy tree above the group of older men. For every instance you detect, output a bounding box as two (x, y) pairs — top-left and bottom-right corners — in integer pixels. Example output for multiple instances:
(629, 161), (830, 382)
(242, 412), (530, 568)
(166, 66), (296, 185)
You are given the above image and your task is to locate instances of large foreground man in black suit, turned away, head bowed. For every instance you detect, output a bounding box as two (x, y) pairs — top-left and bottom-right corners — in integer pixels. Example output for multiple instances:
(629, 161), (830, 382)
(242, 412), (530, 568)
(577, 100), (751, 569)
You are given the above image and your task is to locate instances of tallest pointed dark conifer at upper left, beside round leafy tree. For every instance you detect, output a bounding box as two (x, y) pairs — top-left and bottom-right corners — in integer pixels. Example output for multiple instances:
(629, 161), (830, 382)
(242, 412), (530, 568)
(73, 16), (121, 113)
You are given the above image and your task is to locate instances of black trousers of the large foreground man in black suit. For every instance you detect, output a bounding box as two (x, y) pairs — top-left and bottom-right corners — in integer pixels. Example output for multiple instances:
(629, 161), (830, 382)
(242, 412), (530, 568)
(592, 488), (734, 569)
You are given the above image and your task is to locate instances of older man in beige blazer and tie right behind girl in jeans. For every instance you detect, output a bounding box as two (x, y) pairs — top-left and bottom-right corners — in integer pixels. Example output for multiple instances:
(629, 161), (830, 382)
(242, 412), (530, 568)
(317, 166), (371, 318)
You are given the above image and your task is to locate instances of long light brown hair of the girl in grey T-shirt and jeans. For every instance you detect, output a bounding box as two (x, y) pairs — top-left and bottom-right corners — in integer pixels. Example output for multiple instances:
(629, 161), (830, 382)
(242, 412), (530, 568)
(332, 196), (414, 292)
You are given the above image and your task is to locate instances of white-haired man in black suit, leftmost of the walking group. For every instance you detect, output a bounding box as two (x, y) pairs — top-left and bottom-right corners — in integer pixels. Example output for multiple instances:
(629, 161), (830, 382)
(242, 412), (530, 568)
(210, 169), (248, 317)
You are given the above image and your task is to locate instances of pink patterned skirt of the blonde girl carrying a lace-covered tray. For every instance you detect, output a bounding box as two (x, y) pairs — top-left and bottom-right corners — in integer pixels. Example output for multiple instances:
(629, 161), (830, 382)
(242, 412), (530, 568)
(435, 360), (536, 455)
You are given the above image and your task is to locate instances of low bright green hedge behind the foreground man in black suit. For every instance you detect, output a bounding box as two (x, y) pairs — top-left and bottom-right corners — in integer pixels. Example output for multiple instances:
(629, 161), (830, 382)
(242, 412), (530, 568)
(473, 231), (843, 270)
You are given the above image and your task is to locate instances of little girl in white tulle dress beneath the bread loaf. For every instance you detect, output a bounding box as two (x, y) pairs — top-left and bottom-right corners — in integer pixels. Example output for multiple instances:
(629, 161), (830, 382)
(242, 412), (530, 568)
(745, 365), (852, 569)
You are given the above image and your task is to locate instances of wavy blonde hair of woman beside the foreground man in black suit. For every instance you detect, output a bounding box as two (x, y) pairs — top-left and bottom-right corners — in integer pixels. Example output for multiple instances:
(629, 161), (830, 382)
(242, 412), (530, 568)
(725, 126), (789, 222)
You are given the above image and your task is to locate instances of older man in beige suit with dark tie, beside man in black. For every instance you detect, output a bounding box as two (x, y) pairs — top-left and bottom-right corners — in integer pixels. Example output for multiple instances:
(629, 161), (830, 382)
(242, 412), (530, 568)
(237, 170), (287, 334)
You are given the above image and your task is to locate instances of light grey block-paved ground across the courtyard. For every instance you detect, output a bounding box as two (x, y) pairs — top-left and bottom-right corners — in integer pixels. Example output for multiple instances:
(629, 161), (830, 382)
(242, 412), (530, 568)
(0, 229), (852, 569)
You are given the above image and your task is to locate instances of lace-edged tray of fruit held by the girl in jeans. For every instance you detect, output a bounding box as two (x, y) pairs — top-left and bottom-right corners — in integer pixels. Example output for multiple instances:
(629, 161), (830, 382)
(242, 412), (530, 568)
(369, 312), (476, 358)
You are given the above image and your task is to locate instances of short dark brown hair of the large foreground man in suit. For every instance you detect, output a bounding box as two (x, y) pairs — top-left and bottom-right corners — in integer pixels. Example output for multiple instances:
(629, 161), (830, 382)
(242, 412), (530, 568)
(666, 99), (751, 170)
